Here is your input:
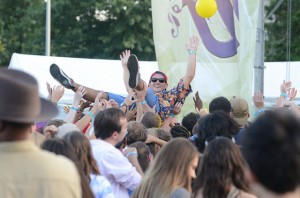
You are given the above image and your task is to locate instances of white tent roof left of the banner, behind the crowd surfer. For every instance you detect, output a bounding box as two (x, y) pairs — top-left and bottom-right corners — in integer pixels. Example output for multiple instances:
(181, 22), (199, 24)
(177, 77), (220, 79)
(9, 53), (158, 104)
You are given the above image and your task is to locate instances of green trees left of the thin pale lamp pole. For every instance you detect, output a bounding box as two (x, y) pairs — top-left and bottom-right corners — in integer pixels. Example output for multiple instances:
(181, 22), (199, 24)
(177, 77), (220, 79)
(0, 0), (45, 66)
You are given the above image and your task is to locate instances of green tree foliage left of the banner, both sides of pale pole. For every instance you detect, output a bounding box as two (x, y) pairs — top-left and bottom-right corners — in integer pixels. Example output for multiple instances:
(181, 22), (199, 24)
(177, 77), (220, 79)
(0, 0), (155, 65)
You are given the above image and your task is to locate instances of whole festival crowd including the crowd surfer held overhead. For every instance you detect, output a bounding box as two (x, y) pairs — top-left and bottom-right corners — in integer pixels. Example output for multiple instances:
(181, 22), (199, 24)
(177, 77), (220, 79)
(0, 37), (300, 198)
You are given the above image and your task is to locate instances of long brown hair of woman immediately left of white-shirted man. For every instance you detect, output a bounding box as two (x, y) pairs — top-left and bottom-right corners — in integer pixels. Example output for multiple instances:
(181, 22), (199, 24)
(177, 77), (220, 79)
(63, 132), (100, 181)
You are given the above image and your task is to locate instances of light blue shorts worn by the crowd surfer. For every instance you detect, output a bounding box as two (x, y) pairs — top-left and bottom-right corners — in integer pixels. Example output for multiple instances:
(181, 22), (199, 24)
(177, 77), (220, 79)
(107, 88), (159, 112)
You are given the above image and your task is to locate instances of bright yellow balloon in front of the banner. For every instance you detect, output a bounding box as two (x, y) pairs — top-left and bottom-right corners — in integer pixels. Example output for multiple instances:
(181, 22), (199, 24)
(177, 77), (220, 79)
(196, 0), (218, 18)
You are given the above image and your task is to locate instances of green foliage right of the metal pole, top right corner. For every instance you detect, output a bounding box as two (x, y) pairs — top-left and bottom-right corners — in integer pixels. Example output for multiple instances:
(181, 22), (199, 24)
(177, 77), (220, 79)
(265, 0), (300, 61)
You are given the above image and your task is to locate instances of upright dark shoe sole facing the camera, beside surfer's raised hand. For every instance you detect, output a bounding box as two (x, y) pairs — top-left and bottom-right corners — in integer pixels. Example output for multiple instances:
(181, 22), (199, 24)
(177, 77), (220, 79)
(127, 54), (139, 89)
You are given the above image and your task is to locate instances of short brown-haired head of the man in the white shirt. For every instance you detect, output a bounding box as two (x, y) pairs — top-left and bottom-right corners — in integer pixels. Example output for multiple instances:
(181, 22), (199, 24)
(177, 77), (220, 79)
(94, 108), (126, 140)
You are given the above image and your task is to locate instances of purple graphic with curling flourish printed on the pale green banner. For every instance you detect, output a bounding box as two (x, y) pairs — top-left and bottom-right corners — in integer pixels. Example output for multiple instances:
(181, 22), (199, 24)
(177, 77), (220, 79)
(168, 0), (239, 58)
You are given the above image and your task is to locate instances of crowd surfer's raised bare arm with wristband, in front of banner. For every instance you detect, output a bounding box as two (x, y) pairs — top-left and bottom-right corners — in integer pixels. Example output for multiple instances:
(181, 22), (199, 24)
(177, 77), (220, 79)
(183, 36), (199, 88)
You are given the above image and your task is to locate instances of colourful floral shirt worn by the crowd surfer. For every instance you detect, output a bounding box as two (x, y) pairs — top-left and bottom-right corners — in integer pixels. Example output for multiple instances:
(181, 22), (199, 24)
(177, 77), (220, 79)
(155, 79), (192, 122)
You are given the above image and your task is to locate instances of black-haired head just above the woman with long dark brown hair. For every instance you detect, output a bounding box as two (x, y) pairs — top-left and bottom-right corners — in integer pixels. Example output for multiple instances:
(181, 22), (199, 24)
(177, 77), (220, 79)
(196, 111), (239, 152)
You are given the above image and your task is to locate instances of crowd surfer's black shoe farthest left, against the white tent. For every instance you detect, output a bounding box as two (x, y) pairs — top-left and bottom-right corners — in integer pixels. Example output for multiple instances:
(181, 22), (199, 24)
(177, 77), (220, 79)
(50, 64), (75, 89)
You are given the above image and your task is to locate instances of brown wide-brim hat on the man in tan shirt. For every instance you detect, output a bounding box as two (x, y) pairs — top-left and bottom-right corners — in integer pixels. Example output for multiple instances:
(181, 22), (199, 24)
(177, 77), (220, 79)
(0, 68), (58, 123)
